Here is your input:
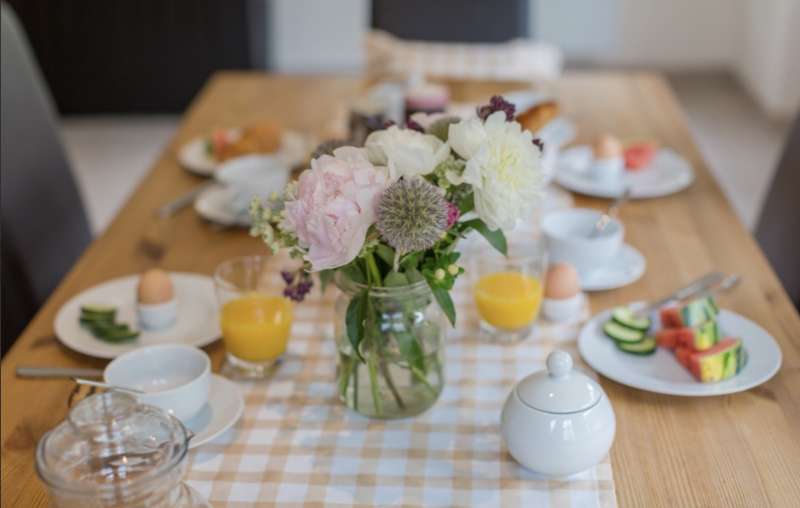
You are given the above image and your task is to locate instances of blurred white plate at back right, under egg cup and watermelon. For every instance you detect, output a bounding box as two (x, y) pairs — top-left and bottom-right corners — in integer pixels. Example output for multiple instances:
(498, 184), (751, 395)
(555, 145), (694, 199)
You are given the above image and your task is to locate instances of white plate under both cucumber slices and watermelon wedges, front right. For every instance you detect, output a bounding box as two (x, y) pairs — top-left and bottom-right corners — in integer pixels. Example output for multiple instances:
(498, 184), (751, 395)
(578, 309), (781, 397)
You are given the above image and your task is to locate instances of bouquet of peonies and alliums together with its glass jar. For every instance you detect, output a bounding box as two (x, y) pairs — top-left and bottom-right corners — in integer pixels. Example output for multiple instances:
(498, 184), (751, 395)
(251, 97), (541, 418)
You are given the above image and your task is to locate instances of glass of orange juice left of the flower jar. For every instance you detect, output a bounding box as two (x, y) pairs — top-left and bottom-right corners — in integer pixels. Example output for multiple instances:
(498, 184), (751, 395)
(214, 256), (294, 379)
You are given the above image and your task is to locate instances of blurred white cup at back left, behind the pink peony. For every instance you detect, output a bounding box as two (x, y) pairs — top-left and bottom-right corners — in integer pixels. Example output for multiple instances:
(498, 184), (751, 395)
(214, 155), (289, 213)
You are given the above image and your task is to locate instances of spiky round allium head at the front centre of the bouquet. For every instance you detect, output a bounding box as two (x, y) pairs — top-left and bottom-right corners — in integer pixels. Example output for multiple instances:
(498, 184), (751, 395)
(377, 178), (448, 254)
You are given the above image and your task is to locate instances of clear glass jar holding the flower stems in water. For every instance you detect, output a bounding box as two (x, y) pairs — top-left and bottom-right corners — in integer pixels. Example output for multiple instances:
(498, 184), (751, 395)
(335, 273), (449, 419)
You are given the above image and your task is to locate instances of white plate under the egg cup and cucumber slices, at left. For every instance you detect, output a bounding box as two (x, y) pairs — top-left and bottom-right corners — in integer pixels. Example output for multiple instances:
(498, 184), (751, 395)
(54, 272), (221, 358)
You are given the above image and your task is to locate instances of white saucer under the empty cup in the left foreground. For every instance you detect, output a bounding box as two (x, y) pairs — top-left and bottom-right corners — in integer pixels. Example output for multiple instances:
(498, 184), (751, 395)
(185, 374), (244, 449)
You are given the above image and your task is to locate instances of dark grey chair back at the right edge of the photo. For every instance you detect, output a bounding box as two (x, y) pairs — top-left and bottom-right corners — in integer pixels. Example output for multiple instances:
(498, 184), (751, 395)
(756, 115), (800, 309)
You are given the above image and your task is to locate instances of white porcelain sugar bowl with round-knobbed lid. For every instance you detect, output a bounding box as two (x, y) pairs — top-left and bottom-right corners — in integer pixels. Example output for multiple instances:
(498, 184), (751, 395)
(501, 350), (616, 476)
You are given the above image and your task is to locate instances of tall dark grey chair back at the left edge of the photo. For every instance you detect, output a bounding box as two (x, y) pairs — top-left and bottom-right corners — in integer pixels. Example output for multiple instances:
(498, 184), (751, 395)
(0, 3), (91, 351)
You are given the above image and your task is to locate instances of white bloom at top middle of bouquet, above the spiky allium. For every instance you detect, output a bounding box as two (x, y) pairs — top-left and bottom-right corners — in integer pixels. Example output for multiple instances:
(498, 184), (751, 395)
(365, 125), (450, 179)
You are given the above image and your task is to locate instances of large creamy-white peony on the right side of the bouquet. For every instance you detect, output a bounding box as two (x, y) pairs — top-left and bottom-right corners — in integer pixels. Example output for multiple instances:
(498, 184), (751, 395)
(460, 111), (542, 230)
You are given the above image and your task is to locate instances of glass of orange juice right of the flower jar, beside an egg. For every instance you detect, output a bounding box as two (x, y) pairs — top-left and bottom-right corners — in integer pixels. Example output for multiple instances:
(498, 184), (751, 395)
(473, 241), (547, 342)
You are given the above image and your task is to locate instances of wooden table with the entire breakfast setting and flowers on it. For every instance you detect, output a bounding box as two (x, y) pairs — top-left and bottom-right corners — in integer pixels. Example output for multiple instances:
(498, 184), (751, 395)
(2, 2), (800, 508)
